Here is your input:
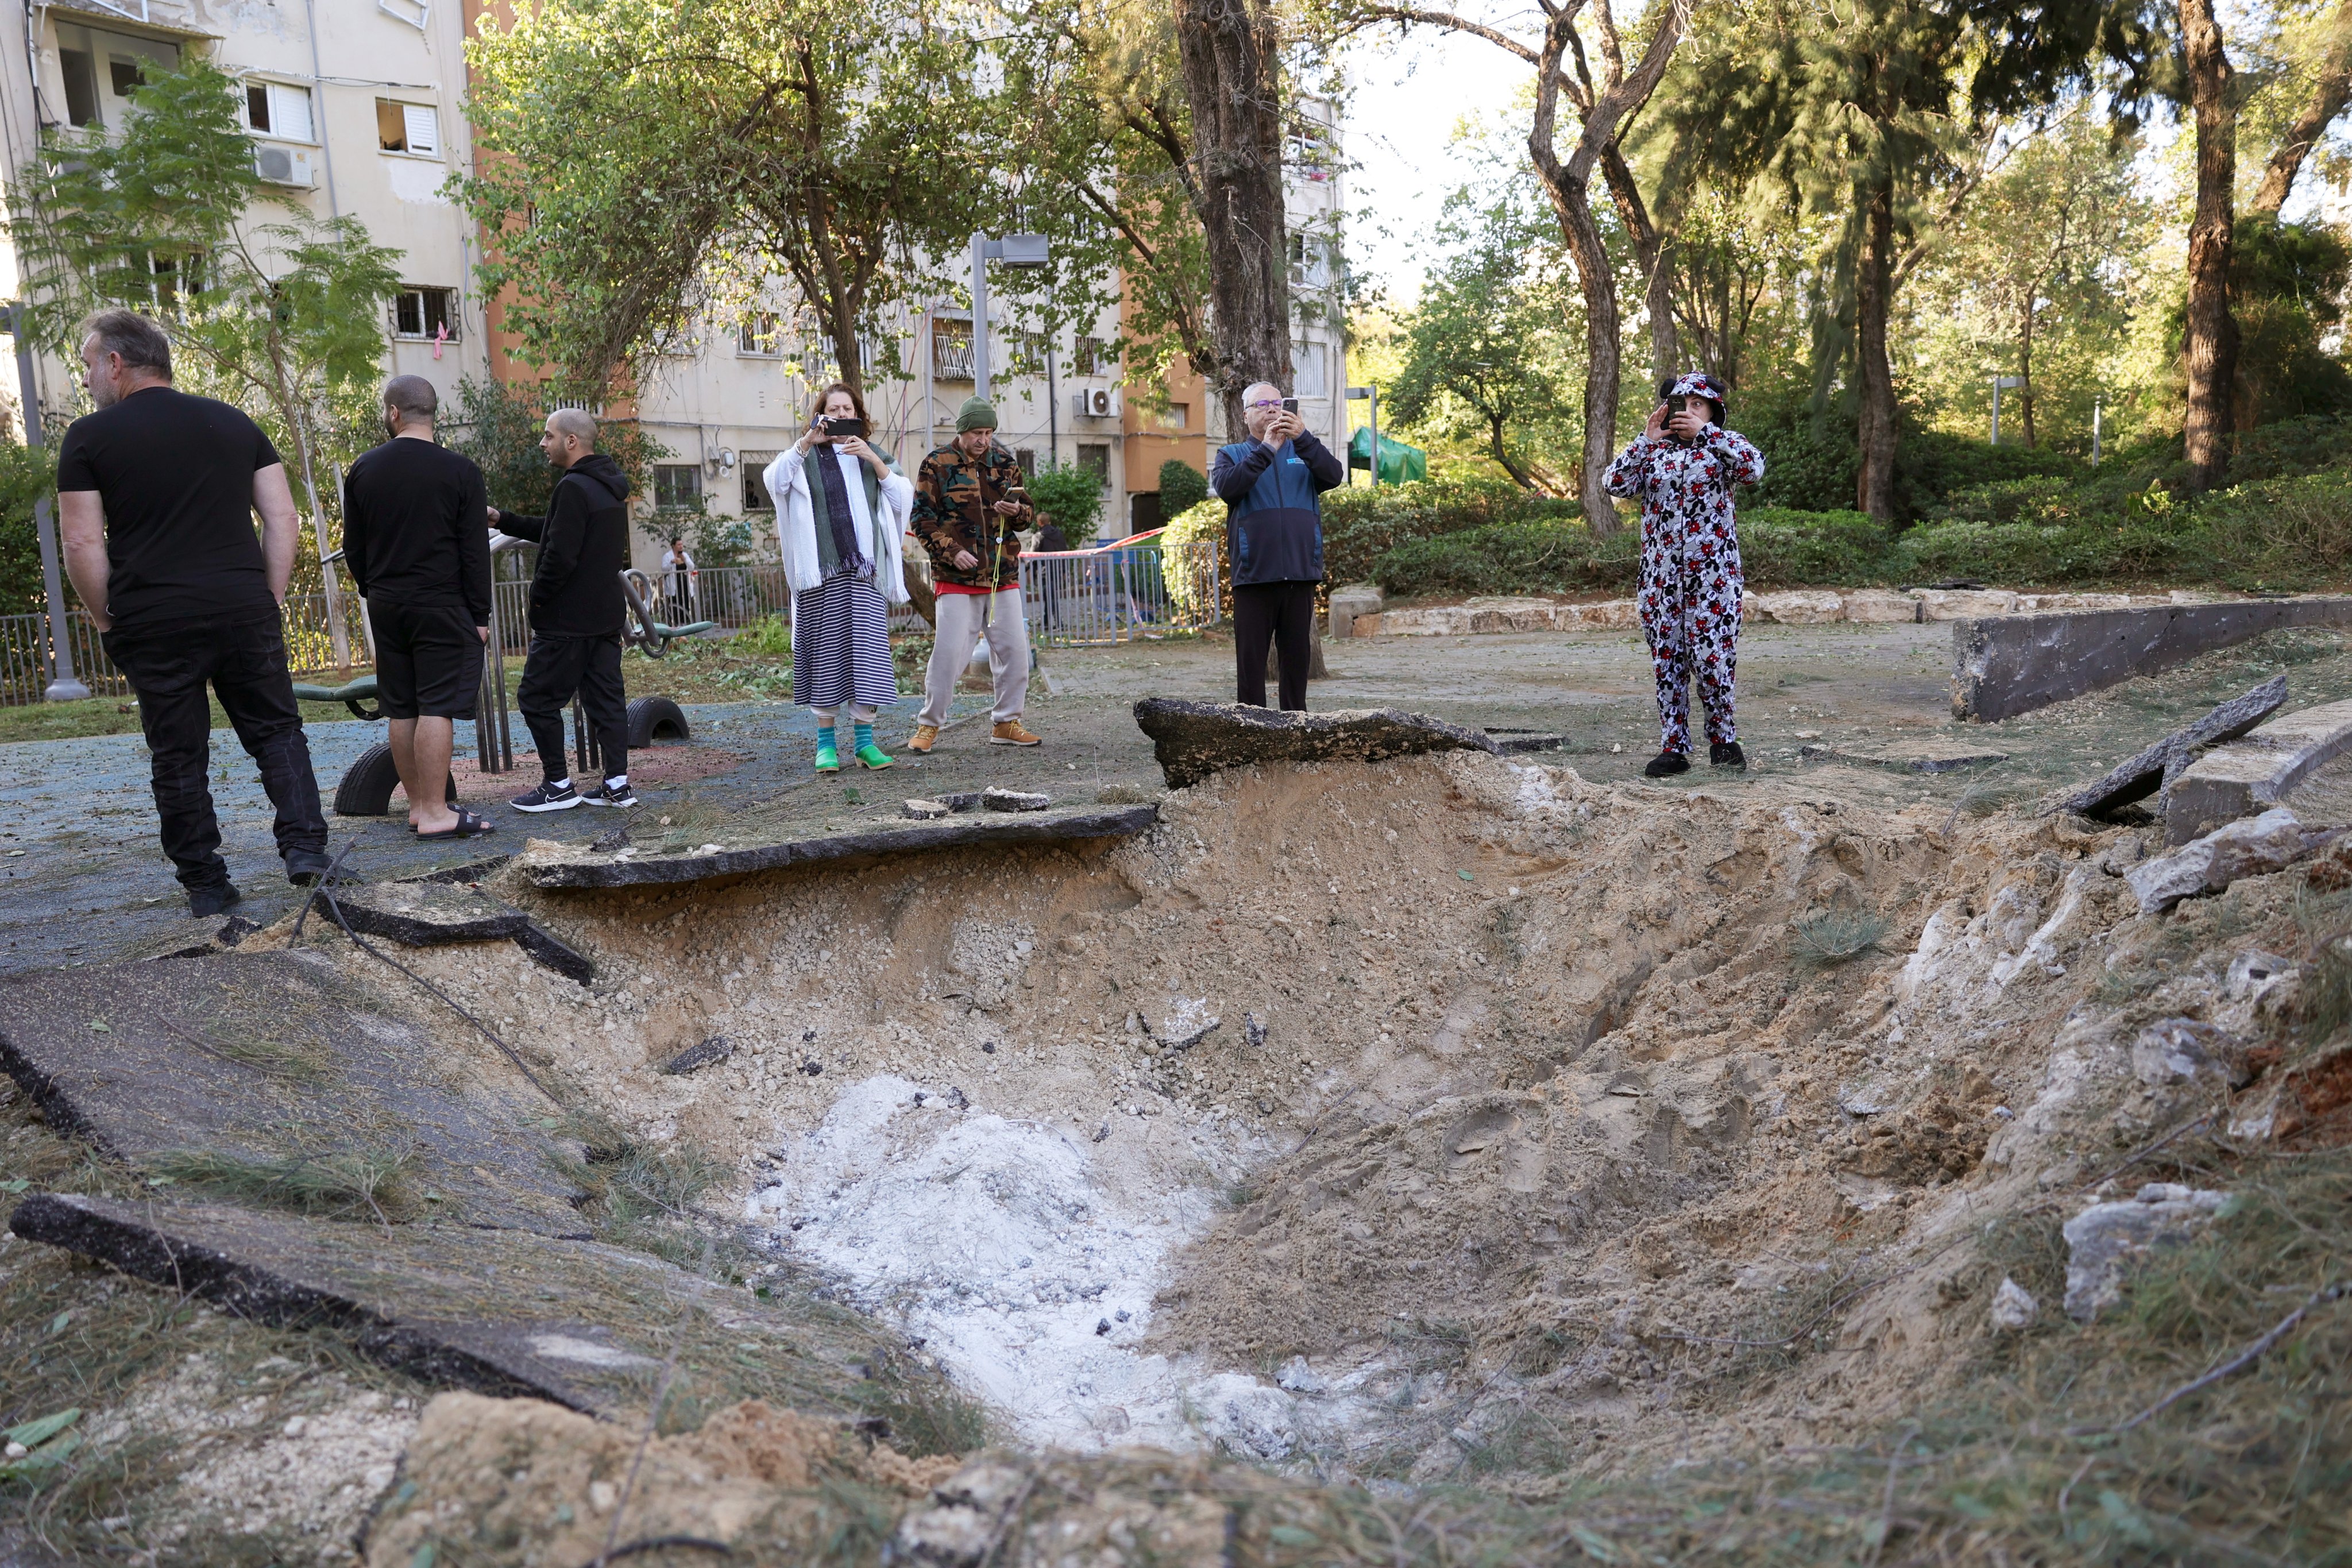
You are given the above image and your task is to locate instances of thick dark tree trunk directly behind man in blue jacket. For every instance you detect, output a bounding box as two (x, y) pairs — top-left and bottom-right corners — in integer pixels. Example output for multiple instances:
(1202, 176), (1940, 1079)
(1176, 0), (1291, 430)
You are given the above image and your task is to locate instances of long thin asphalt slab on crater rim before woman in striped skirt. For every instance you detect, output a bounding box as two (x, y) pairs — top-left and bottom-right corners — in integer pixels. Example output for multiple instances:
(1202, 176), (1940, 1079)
(513, 806), (1160, 889)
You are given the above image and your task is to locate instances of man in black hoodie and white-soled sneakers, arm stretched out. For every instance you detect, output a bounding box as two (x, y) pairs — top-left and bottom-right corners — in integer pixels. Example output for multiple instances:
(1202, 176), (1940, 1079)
(489, 409), (638, 811)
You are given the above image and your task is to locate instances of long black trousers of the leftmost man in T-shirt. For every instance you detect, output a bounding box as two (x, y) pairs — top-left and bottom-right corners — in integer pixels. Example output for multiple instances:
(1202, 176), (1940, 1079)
(103, 613), (327, 889)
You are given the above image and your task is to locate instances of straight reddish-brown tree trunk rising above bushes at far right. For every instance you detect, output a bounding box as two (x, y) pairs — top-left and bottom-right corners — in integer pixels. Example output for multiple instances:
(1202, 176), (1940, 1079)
(2180, 0), (2237, 491)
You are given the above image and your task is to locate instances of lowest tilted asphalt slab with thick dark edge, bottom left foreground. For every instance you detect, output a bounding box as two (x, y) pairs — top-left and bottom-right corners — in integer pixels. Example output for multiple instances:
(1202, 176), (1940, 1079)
(9, 1192), (879, 1420)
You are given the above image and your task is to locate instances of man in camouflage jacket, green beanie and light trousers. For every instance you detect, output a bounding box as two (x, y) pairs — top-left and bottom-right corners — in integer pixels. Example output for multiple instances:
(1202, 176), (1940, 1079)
(908, 397), (1037, 752)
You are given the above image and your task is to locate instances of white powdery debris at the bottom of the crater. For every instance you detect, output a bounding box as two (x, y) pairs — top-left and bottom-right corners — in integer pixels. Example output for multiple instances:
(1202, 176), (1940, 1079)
(748, 1074), (1298, 1458)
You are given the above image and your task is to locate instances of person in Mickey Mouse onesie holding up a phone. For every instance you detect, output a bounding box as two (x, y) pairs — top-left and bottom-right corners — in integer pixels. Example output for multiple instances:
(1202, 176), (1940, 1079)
(1606, 372), (1764, 778)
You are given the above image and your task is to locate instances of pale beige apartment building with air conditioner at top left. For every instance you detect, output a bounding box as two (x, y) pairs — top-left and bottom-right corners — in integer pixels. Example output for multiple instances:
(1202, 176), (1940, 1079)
(0, 0), (489, 435)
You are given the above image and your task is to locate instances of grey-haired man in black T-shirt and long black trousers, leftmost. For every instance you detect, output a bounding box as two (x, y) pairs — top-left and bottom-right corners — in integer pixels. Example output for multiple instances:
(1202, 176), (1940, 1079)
(56, 310), (329, 914)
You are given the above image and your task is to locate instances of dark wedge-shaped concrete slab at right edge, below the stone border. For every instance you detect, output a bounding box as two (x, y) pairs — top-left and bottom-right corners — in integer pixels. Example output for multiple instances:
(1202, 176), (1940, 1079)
(1931, 597), (2352, 722)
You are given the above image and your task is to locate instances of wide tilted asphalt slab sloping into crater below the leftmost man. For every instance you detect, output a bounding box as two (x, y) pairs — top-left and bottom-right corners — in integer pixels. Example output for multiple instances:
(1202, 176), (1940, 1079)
(0, 952), (586, 1234)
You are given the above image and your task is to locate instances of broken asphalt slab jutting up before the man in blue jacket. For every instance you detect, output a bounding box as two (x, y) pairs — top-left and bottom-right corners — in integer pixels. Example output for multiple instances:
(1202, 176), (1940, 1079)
(1136, 696), (1501, 790)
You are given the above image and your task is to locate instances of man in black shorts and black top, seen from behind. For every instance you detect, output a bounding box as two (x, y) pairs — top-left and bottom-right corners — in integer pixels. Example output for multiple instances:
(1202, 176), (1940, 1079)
(343, 376), (492, 839)
